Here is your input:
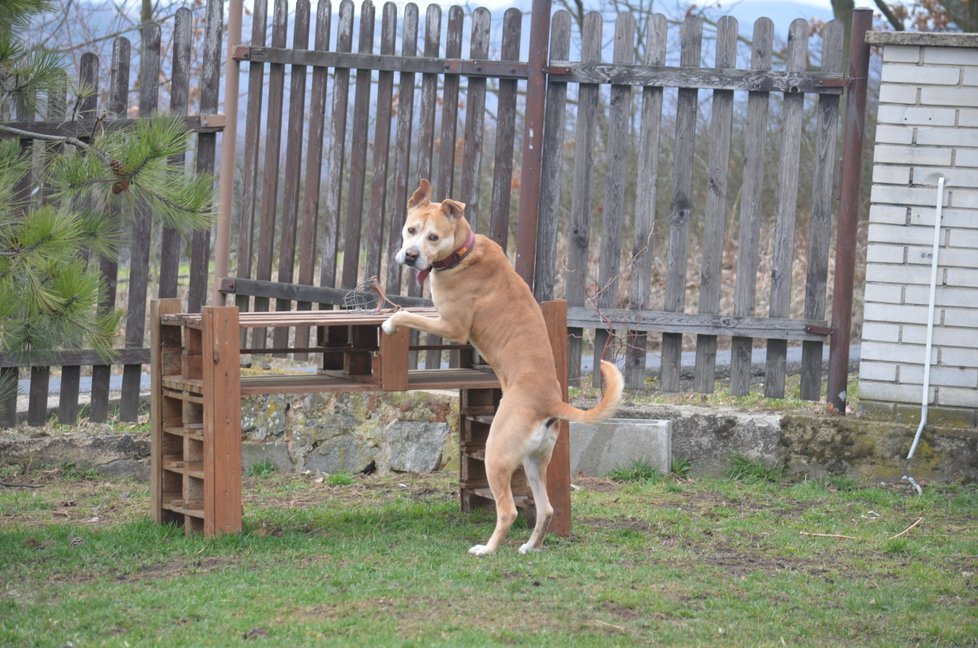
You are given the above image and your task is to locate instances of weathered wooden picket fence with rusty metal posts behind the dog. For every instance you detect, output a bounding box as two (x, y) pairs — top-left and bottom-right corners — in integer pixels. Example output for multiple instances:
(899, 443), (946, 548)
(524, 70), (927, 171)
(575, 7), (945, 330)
(4, 0), (847, 430)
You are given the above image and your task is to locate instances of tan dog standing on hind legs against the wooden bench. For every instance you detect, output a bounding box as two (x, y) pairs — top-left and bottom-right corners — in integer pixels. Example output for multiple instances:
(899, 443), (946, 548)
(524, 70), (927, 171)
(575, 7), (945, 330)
(383, 180), (623, 555)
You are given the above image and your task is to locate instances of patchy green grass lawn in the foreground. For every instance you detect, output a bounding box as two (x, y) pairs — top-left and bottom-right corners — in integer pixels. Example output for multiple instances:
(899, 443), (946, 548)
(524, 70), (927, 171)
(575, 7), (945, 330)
(0, 470), (978, 646)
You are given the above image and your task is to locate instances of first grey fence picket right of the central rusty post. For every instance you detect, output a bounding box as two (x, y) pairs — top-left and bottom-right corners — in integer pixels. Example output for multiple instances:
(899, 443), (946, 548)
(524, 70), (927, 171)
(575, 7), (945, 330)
(533, 11), (571, 301)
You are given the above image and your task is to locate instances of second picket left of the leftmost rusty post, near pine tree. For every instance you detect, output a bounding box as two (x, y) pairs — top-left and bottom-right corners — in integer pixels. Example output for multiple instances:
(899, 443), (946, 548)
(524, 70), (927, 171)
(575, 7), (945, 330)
(156, 7), (193, 297)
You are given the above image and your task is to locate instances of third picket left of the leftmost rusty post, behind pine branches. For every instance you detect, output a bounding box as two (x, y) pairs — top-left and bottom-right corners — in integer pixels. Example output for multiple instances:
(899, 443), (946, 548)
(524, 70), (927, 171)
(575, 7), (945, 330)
(119, 23), (161, 422)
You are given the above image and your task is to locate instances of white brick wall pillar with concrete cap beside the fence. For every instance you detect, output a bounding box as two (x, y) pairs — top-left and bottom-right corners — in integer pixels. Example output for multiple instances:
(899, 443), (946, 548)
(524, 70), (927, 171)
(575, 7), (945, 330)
(859, 34), (978, 410)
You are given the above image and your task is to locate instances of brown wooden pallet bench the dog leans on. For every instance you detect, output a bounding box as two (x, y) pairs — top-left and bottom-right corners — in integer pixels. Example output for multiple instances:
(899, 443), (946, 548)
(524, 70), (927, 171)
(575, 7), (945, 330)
(151, 299), (570, 536)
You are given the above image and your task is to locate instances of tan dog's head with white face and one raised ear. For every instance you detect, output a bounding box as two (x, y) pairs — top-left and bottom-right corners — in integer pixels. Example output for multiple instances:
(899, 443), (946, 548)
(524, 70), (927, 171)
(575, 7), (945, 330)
(394, 179), (469, 270)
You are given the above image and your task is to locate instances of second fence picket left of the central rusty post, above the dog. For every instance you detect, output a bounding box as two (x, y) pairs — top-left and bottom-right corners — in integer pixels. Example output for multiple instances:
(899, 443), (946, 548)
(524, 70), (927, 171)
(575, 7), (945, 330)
(462, 7), (492, 231)
